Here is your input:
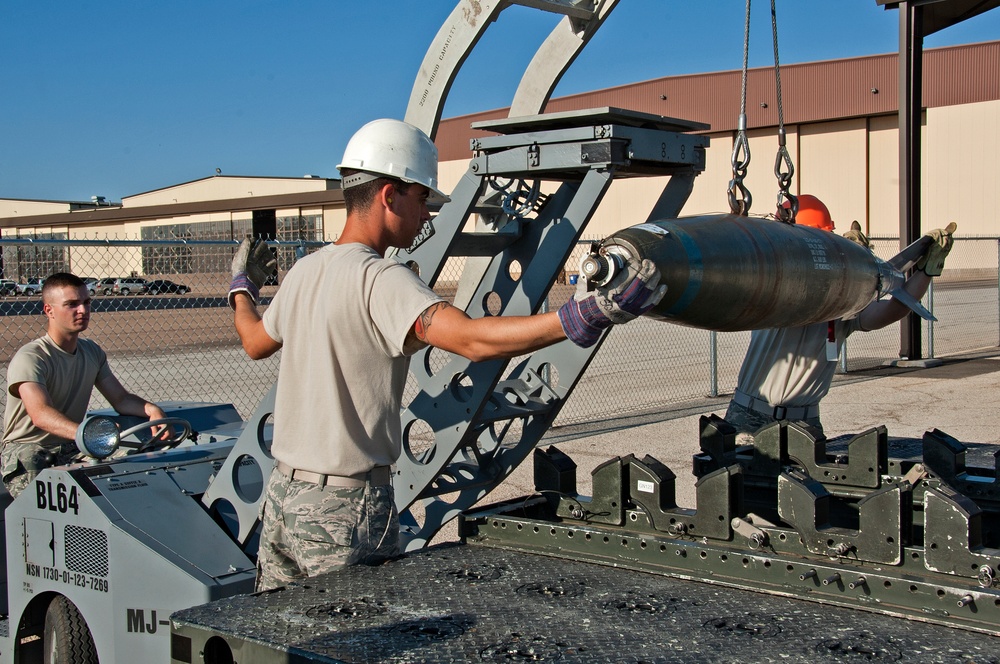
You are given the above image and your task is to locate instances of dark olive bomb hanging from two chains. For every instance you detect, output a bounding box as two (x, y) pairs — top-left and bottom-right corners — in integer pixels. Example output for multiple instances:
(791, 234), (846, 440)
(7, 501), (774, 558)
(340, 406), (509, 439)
(580, 215), (929, 332)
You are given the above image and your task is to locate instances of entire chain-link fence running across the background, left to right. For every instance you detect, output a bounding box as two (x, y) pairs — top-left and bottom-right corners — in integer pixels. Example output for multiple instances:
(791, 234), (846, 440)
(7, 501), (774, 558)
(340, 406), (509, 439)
(0, 236), (1000, 424)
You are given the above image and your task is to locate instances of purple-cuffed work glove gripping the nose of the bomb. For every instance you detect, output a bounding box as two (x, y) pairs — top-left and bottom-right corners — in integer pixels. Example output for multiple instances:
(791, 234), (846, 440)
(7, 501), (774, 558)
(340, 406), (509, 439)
(559, 259), (667, 348)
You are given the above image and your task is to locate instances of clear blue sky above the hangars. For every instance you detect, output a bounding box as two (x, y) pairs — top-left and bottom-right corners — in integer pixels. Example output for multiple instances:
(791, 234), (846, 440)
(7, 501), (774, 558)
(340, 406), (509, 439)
(0, 0), (1000, 201)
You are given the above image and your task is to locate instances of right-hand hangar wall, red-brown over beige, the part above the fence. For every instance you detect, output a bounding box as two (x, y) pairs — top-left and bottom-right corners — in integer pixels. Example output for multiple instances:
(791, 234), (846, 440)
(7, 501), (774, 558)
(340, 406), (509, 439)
(438, 42), (1000, 241)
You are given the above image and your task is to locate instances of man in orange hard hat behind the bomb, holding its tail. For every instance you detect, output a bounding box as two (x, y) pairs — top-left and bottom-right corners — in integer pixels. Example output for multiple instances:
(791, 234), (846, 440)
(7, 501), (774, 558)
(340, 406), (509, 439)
(725, 194), (952, 433)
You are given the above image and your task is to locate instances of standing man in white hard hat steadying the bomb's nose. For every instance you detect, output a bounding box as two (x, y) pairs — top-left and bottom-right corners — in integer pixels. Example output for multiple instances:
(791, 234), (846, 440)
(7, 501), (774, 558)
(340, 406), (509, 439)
(229, 120), (663, 590)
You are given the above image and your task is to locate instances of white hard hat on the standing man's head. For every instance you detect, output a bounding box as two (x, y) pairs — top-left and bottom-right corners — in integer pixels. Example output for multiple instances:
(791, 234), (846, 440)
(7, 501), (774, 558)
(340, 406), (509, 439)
(337, 119), (451, 203)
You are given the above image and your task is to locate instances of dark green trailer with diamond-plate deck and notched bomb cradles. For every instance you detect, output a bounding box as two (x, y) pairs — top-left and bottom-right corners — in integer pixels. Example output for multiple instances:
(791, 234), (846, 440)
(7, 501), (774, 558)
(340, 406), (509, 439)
(171, 417), (1000, 664)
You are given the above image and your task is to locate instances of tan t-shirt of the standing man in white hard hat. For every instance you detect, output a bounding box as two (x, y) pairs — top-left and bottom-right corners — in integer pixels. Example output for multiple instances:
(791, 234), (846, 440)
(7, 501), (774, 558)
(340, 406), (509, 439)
(264, 244), (441, 475)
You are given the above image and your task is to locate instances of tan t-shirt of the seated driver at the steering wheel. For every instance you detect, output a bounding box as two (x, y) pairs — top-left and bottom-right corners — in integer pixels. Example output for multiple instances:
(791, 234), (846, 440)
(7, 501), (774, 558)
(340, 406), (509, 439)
(3, 335), (111, 447)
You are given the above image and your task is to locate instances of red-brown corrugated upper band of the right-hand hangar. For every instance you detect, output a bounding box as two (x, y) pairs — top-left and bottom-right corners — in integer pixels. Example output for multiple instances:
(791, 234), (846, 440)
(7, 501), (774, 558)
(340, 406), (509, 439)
(437, 41), (1000, 160)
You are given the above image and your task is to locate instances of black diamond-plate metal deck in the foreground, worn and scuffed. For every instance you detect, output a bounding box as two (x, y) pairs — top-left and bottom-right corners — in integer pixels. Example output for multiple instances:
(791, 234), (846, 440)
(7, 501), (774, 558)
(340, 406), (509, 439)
(173, 544), (1000, 664)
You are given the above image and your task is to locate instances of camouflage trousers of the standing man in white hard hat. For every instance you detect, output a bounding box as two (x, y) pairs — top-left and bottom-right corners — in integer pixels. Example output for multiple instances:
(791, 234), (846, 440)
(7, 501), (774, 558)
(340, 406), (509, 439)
(257, 470), (399, 591)
